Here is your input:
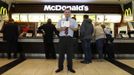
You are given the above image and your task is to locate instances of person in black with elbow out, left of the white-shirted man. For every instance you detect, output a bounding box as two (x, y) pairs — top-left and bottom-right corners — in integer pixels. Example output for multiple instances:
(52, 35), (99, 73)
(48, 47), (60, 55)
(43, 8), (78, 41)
(38, 19), (59, 59)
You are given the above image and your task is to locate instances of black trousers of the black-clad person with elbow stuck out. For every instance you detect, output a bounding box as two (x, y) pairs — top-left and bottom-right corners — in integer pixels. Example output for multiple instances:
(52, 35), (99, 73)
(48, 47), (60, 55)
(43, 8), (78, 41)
(44, 39), (56, 59)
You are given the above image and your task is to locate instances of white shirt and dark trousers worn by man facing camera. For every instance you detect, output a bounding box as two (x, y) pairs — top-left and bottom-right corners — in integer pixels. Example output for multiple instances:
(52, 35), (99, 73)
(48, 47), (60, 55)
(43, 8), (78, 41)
(56, 17), (78, 70)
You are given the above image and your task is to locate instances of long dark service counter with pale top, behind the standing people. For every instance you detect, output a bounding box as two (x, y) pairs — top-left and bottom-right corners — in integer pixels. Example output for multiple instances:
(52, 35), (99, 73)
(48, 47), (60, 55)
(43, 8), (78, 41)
(0, 38), (134, 54)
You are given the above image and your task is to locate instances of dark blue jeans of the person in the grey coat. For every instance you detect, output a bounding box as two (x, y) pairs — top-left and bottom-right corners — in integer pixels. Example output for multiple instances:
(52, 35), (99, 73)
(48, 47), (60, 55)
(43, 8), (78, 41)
(82, 39), (92, 61)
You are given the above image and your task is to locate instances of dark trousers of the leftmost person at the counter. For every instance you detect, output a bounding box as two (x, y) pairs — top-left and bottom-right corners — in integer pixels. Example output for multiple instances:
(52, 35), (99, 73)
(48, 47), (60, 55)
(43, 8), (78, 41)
(7, 41), (18, 58)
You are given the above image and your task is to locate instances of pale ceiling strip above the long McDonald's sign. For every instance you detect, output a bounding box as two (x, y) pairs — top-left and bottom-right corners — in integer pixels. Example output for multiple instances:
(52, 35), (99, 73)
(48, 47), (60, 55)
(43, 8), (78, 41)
(2, 0), (132, 4)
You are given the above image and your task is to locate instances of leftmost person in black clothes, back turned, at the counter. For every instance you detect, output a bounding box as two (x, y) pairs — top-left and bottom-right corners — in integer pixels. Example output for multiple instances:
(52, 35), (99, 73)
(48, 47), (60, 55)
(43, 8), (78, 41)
(3, 19), (19, 59)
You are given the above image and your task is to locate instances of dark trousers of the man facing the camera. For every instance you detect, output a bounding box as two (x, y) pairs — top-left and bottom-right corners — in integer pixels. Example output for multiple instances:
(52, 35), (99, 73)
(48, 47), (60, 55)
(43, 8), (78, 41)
(58, 37), (73, 69)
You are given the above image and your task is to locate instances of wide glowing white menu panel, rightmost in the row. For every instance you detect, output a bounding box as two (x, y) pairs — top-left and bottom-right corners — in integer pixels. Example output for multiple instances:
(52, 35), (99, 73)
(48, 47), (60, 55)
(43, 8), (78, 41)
(104, 15), (121, 23)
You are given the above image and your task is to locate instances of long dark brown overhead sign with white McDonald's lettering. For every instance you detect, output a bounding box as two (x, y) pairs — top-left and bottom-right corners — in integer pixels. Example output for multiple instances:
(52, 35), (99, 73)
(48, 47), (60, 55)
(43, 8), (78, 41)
(10, 3), (122, 13)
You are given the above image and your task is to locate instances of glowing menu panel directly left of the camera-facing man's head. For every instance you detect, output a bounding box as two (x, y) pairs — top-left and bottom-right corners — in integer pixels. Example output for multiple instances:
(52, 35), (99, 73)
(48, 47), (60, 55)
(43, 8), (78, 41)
(45, 14), (62, 22)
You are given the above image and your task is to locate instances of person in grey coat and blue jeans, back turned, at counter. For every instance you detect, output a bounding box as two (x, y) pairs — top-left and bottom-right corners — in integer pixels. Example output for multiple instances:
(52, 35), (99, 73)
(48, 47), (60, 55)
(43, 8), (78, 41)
(80, 15), (94, 64)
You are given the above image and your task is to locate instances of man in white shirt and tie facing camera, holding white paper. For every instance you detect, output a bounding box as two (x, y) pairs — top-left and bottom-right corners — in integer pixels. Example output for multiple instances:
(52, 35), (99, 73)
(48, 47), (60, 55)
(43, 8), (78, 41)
(56, 9), (78, 73)
